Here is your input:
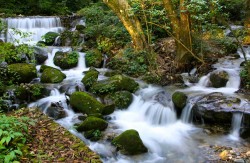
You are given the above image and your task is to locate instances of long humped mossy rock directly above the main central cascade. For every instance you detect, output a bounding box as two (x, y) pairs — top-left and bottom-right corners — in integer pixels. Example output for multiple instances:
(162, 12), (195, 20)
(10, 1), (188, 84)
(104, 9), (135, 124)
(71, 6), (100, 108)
(90, 75), (139, 95)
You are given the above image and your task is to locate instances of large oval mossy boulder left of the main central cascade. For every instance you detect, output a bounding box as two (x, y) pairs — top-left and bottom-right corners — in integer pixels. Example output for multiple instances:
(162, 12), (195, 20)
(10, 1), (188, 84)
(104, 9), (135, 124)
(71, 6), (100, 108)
(70, 92), (104, 115)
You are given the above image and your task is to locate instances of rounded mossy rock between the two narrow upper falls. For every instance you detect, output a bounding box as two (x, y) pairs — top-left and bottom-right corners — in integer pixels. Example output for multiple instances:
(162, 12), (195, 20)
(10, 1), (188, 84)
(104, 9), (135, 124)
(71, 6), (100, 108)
(53, 51), (79, 69)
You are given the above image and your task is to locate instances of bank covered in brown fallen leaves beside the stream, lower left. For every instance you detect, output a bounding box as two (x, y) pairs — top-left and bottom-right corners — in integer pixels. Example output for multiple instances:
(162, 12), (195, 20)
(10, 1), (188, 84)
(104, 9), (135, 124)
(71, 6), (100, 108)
(12, 109), (101, 163)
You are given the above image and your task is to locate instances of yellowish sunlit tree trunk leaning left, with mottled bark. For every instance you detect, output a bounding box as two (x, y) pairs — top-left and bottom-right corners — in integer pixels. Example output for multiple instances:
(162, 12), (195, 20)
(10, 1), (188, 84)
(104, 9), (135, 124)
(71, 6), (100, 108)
(103, 0), (148, 50)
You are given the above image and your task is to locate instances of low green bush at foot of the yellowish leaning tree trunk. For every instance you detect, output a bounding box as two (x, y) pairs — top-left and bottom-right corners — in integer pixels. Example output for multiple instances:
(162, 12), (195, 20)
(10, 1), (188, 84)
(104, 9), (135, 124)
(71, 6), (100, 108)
(107, 48), (149, 77)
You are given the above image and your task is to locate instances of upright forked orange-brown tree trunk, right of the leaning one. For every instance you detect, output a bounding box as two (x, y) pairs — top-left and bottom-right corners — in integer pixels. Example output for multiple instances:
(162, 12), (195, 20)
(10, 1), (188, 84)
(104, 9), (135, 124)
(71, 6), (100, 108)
(163, 0), (192, 64)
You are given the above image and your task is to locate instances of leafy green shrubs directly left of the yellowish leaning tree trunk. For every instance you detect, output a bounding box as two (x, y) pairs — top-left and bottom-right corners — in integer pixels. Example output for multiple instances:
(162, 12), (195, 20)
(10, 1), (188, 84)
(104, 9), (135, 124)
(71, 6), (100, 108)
(77, 2), (130, 54)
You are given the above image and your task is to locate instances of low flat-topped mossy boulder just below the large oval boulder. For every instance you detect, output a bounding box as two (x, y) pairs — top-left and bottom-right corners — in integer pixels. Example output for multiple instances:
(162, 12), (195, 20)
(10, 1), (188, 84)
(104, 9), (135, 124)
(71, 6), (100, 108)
(76, 116), (108, 131)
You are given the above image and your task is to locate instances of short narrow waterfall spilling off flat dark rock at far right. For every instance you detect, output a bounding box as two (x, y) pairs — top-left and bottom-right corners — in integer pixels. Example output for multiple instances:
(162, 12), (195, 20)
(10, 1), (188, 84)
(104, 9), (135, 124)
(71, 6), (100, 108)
(229, 113), (243, 140)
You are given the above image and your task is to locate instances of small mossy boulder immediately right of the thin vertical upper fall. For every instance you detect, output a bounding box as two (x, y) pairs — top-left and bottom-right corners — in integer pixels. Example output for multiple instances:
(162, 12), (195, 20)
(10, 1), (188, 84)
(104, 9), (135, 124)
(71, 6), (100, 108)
(85, 49), (103, 68)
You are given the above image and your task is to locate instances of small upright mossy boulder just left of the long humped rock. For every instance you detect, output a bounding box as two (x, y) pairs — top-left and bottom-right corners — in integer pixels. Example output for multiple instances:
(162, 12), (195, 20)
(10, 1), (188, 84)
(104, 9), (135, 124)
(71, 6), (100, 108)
(81, 69), (99, 90)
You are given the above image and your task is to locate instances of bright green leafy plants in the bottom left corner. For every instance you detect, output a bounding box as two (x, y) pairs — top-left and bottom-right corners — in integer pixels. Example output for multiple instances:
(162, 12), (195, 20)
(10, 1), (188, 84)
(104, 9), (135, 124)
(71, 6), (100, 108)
(0, 115), (34, 163)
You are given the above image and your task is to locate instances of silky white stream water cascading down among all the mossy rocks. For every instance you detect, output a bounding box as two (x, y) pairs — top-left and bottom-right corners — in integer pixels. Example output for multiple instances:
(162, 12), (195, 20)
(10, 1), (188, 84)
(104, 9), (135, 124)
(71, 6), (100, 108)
(1, 17), (250, 163)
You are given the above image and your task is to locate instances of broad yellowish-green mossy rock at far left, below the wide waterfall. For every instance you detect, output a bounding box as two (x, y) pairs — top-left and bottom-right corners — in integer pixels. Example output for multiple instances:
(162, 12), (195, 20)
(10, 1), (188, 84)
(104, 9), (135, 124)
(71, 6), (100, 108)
(8, 63), (37, 83)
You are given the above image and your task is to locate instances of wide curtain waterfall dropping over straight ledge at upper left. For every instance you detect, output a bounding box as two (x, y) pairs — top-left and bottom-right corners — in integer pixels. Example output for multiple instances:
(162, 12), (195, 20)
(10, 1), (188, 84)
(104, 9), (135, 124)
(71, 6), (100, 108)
(3, 17), (64, 44)
